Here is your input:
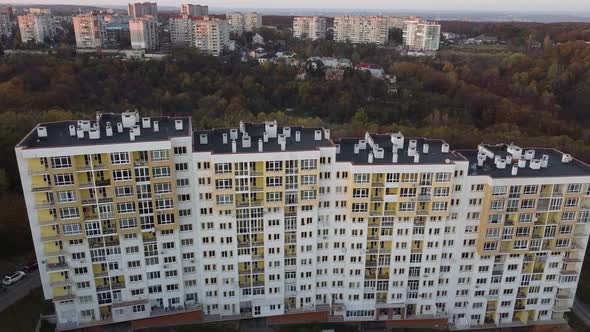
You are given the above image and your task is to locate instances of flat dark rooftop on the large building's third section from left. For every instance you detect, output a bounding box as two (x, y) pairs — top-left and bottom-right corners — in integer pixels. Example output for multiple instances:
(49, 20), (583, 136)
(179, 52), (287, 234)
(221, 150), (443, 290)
(334, 134), (466, 165)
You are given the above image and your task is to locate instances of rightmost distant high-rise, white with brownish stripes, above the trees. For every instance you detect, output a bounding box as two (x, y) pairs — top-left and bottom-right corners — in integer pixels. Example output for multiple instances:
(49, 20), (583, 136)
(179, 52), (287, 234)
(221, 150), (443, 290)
(403, 19), (440, 51)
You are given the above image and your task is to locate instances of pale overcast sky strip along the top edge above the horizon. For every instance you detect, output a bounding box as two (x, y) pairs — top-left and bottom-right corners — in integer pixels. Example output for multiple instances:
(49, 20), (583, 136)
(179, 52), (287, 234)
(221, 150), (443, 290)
(0, 0), (590, 12)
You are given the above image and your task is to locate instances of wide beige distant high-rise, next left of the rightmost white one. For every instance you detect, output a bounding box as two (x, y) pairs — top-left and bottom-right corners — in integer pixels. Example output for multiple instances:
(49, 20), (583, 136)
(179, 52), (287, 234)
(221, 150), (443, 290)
(334, 16), (389, 45)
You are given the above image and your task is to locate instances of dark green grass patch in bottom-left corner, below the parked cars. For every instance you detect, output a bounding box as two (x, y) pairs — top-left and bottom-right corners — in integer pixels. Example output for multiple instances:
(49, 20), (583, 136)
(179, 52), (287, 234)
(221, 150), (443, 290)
(0, 288), (53, 332)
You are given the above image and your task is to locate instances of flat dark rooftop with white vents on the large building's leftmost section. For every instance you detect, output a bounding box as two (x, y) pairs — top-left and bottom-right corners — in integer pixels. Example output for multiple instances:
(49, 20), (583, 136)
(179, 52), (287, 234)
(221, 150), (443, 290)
(17, 112), (191, 149)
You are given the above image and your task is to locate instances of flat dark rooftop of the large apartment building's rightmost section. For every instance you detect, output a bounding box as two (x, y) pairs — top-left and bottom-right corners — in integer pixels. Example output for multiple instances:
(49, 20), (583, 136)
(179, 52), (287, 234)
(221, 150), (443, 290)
(456, 144), (590, 178)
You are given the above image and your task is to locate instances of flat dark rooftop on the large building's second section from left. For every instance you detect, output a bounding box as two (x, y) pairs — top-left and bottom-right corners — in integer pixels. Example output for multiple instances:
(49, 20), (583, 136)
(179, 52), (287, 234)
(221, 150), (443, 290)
(193, 122), (334, 154)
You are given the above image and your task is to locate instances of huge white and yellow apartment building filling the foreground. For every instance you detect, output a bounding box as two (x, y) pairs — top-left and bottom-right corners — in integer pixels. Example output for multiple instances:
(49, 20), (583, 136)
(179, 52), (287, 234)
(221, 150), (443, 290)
(16, 112), (590, 329)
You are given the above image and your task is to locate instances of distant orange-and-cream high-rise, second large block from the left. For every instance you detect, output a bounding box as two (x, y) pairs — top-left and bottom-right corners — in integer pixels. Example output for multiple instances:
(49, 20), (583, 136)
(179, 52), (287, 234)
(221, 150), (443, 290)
(73, 11), (108, 48)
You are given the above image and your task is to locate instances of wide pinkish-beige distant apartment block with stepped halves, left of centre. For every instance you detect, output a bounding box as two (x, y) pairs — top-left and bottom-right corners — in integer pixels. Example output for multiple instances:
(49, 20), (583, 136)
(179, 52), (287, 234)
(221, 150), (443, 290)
(170, 14), (234, 56)
